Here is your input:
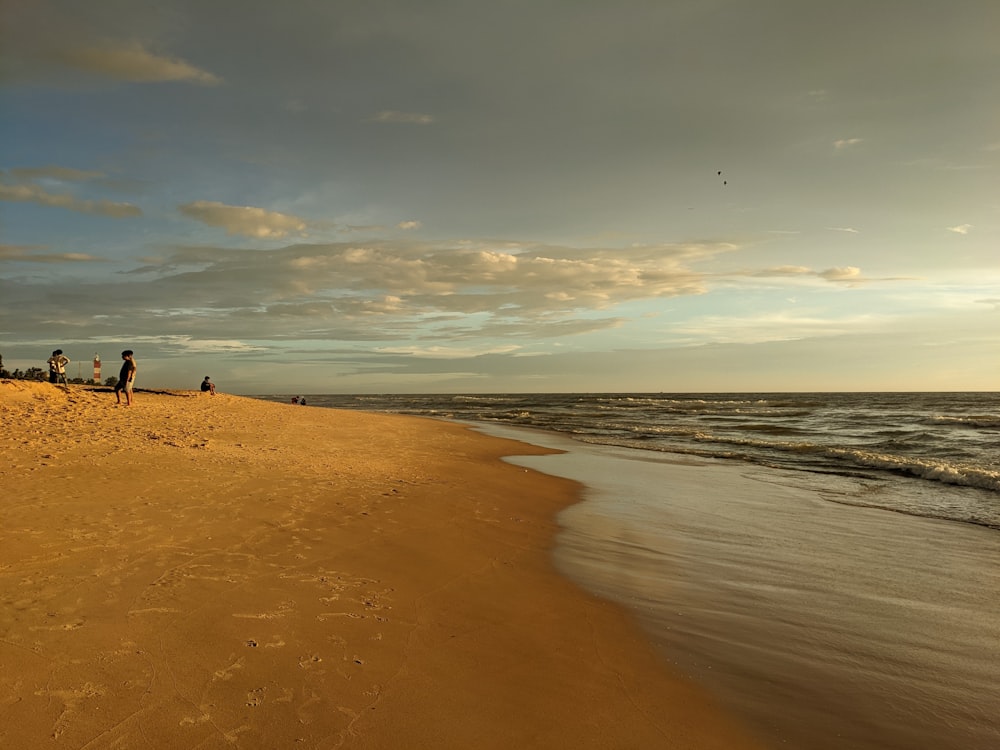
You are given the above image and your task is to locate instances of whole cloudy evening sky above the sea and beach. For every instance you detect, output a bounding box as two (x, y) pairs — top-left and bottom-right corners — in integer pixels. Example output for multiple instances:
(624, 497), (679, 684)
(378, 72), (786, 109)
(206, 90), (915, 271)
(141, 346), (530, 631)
(0, 0), (1000, 394)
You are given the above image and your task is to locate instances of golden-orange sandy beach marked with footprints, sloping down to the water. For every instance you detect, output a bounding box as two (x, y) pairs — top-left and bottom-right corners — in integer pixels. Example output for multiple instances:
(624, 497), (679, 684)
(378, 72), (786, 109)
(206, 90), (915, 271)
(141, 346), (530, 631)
(0, 381), (756, 750)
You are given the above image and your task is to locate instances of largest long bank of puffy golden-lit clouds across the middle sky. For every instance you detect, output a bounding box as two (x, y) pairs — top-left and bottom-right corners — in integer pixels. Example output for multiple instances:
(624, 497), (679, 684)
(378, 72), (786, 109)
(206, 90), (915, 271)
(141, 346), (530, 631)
(93, 239), (735, 341)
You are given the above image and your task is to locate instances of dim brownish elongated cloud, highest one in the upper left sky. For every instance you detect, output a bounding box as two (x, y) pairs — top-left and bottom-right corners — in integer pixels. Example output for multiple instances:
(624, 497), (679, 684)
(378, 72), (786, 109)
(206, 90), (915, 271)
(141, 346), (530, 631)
(54, 41), (222, 86)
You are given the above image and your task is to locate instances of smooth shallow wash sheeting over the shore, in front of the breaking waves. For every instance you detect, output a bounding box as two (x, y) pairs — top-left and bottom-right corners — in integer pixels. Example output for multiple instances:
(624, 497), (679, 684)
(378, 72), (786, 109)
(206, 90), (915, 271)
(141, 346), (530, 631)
(484, 426), (1000, 750)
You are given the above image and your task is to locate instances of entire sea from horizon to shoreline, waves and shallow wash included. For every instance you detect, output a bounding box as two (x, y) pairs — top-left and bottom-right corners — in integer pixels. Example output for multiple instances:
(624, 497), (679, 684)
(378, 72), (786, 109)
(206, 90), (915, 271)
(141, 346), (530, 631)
(252, 393), (1000, 750)
